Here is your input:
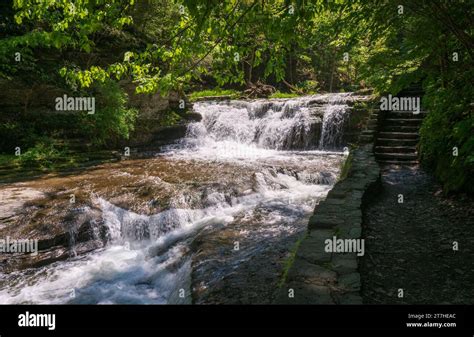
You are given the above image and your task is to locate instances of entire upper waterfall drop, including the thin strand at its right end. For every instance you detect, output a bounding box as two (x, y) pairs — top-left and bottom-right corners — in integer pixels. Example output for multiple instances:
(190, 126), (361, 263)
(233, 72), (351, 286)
(187, 94), (351, 151)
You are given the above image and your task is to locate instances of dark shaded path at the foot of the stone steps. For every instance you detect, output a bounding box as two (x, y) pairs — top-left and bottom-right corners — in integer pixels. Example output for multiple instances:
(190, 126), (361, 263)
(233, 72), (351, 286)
(359, 166), (474, 304)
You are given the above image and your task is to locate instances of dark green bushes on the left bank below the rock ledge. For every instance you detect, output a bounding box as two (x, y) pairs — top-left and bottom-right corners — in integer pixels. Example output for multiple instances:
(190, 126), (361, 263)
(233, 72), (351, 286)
(0, 81), (137, 156)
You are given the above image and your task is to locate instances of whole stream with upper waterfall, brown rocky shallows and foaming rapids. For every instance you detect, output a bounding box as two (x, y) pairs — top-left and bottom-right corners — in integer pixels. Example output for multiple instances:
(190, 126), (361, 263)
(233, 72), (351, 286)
(0, 94), (362, 304)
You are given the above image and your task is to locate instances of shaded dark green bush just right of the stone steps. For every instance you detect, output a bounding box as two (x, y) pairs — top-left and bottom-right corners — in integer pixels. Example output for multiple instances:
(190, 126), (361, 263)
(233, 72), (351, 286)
(420, 71), (474, 193)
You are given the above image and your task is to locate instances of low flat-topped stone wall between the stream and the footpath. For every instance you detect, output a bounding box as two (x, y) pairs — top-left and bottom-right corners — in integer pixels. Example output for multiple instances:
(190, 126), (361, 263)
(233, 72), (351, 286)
(276, 144), (380, 304)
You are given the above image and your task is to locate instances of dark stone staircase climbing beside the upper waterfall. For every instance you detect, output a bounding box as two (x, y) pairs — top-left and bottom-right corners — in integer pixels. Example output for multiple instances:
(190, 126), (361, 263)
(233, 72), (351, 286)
(374, 88), (426, 165)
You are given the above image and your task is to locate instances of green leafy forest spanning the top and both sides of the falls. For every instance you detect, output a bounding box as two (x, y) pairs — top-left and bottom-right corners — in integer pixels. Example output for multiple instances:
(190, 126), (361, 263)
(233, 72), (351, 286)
(0, 0), (474, 192)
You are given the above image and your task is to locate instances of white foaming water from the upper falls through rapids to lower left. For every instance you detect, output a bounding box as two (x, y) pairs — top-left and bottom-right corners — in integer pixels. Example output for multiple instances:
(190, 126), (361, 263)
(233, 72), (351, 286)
(0, 95), (348, 304)
